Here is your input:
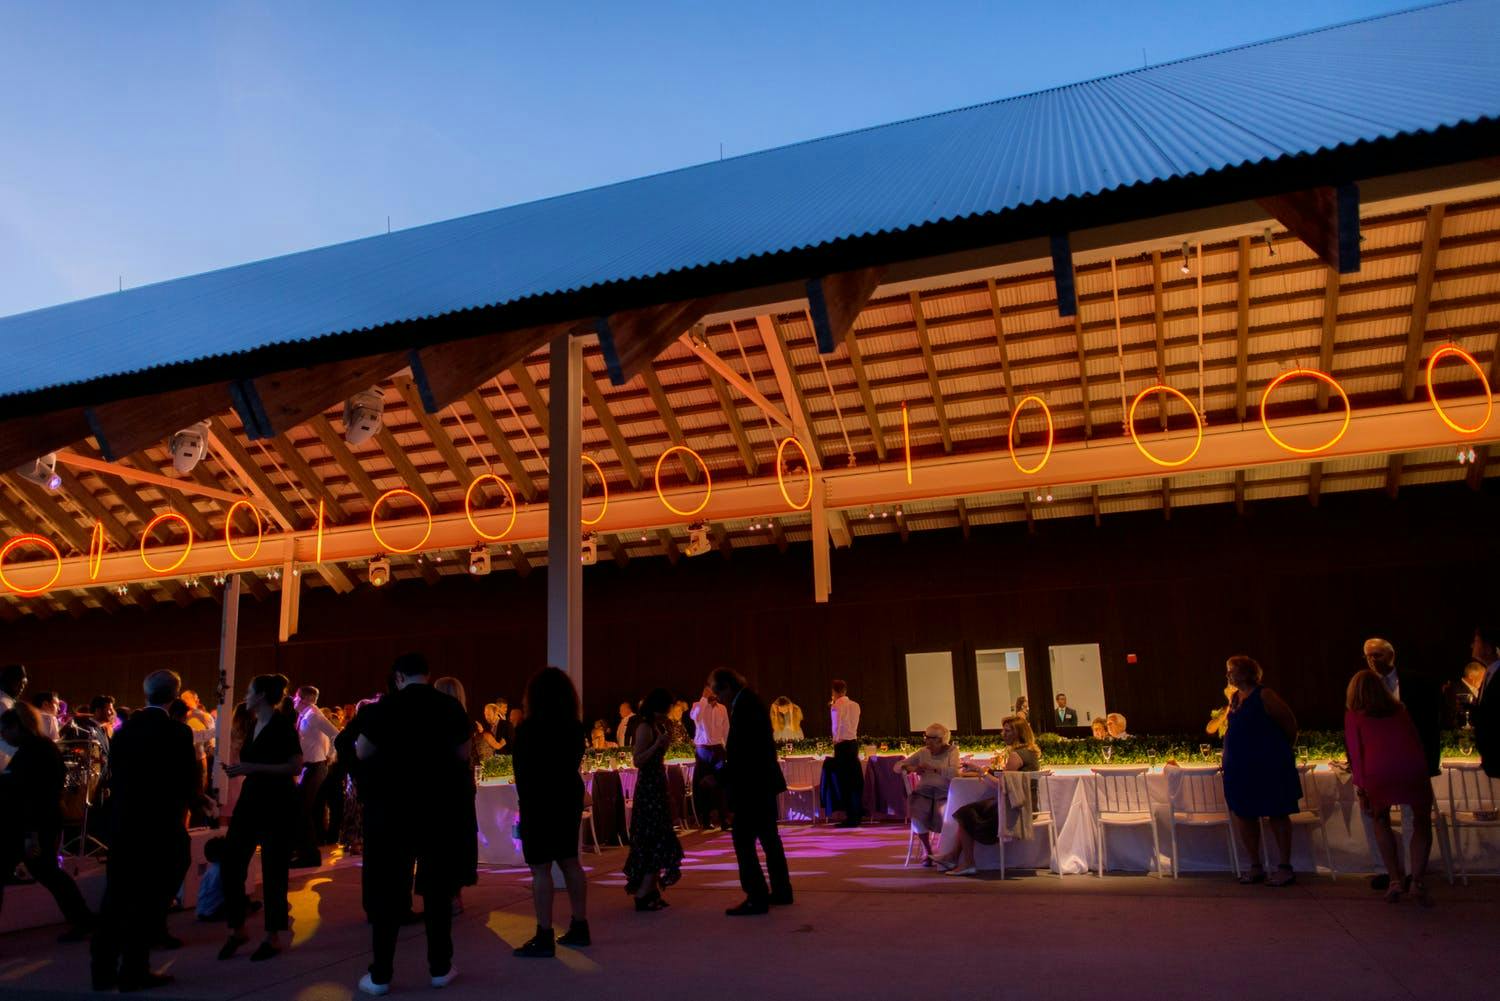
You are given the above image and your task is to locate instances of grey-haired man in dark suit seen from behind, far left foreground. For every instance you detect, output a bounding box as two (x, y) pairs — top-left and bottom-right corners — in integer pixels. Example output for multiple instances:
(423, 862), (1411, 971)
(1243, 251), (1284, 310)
(92, 671), (203, 990)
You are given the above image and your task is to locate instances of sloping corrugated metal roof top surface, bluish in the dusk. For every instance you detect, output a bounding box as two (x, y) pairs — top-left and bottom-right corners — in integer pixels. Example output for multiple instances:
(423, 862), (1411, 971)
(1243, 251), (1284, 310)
(0, 0), (1500, 396)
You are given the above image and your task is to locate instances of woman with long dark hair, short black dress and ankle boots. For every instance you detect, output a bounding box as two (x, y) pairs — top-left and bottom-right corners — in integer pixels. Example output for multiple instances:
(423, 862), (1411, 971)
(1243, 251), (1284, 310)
(513, 668), (590, 959)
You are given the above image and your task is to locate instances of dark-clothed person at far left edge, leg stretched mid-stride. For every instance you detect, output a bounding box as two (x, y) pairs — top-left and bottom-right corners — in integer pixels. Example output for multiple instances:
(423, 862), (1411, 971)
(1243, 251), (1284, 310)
(0, 702), (95, 942)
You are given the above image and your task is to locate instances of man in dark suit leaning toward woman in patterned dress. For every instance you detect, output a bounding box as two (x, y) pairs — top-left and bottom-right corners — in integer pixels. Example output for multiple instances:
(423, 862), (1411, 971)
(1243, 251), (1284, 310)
(708, 668), (792, 917)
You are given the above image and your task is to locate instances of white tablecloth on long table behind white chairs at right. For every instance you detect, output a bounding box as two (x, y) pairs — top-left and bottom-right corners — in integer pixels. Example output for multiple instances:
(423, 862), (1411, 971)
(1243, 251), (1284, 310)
(939, 765), (1500, 873)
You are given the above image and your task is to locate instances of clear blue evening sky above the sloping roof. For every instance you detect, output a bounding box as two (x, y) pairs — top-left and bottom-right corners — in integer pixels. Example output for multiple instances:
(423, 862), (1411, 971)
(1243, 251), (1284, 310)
(0, 0), (1412, 315)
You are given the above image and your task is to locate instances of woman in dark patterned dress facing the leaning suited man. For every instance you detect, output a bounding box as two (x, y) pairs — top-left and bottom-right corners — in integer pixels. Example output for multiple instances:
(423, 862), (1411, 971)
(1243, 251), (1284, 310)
(624, 689), (683, 911)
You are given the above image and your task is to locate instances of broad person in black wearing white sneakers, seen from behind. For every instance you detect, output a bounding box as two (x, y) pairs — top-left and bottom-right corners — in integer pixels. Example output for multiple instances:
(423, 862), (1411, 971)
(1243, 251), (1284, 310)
(354, 653), (477, 996)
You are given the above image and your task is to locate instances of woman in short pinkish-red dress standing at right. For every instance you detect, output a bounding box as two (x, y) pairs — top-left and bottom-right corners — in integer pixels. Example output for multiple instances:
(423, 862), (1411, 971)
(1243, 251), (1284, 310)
(1344, 671), (1433, 906)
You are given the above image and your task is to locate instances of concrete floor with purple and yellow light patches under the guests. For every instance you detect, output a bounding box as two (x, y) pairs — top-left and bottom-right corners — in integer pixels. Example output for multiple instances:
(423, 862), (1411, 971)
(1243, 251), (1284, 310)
(0, 825), (1500, 1001)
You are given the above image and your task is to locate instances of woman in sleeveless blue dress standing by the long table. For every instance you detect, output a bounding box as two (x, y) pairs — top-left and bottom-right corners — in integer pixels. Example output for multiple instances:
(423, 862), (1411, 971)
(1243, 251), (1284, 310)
(1224, 657), (1302, 887)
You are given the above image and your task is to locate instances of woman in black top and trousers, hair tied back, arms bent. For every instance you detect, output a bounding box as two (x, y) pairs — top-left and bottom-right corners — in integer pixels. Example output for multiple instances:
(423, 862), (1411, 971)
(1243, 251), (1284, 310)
(219, 674), (302, 962)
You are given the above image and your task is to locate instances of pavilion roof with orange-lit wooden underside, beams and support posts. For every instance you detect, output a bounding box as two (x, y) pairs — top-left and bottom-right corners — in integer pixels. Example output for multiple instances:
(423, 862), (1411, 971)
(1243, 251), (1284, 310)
(0, 0), (1500, 780)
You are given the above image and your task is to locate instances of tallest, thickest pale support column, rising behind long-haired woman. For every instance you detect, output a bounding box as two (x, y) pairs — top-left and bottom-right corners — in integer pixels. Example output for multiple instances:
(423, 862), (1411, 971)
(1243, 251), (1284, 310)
(548, 333), (584, 693)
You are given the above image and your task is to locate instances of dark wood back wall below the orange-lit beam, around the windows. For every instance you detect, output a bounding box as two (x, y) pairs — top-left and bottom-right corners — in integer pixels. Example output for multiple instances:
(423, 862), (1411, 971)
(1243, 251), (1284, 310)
(0, 488), (1500, 734)
